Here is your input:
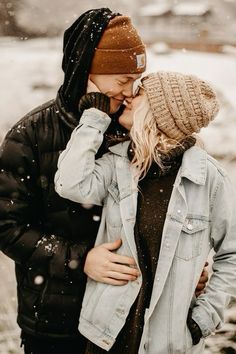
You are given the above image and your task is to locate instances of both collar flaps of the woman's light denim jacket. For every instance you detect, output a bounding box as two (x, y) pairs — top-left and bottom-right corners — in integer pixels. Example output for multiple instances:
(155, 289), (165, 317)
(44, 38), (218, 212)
(109, 140), (207, 185)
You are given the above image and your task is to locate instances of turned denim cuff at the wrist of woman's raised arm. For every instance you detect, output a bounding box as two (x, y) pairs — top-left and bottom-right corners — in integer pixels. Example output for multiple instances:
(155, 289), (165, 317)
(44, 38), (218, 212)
(77, 108), (111, 133)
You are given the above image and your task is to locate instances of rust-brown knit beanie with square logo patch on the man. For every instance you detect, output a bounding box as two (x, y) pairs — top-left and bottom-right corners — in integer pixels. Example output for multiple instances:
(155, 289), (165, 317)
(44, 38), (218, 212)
(90, 16), (146, 74)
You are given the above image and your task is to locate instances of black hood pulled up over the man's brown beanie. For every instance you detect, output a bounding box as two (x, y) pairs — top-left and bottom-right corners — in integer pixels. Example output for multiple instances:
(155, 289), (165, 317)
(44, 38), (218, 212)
(59, 8), (119, 118)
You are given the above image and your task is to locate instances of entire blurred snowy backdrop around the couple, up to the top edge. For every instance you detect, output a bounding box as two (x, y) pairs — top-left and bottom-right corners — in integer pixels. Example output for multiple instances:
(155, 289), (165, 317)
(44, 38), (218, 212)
(0, 0), (236, 354)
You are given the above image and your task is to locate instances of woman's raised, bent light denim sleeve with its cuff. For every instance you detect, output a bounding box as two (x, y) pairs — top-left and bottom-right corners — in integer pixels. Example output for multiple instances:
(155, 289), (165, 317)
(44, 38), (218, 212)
(55, 108), (114, 205)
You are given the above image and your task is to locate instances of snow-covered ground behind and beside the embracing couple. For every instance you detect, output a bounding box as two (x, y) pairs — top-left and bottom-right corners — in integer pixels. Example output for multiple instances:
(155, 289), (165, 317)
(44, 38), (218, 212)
(0, 38), (236, 354)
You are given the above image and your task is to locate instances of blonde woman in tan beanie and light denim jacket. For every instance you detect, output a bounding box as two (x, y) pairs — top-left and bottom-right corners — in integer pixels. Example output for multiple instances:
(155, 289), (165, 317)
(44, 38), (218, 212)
(55, 72), (236, 354)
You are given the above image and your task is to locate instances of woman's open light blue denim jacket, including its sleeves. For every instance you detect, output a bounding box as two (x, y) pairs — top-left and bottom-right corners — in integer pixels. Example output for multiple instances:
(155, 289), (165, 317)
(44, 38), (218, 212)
(55, 109), (236, 354)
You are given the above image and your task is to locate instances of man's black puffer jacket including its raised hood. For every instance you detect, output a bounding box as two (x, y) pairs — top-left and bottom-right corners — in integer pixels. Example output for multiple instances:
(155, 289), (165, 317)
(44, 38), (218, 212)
(0, 9), (118, 338)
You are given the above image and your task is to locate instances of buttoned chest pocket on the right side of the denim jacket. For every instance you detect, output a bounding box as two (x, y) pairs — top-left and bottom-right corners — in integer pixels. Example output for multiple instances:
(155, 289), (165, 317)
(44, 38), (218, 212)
(176, 216), (209, 261)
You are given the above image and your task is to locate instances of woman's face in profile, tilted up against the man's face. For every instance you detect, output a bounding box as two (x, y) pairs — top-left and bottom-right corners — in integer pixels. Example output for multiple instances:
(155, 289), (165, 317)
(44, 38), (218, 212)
(119, 88), (146, 130)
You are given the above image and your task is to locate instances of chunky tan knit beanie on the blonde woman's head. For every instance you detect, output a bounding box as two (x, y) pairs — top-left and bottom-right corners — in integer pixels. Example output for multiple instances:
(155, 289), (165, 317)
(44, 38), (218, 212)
(142, 72), (219, 141)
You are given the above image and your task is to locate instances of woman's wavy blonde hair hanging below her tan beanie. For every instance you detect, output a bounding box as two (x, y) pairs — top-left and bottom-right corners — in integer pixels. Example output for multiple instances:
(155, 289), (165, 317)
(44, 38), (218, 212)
(129, 94), (181, 179)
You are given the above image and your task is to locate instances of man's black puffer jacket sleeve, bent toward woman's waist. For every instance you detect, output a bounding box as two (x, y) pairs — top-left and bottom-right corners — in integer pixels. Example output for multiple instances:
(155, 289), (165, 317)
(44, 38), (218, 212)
(0, 120), (93, 279)
